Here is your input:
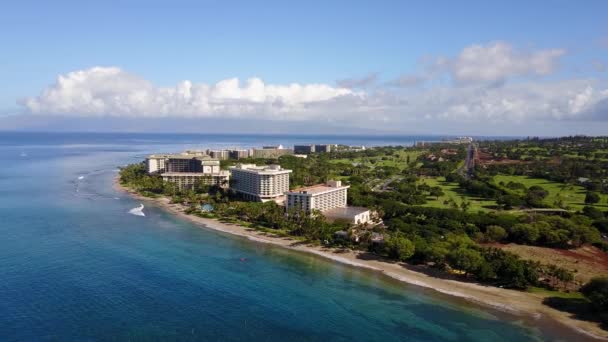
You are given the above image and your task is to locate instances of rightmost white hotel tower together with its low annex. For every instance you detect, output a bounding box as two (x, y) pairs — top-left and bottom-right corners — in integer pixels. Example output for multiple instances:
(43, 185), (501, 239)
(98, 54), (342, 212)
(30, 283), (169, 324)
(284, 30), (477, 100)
(285, 181), (370, 224)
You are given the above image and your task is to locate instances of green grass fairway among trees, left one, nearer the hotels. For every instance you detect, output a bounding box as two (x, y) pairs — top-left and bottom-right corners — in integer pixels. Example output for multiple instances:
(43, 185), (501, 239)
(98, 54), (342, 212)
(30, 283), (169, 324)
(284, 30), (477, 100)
(418, 177), (496, 211)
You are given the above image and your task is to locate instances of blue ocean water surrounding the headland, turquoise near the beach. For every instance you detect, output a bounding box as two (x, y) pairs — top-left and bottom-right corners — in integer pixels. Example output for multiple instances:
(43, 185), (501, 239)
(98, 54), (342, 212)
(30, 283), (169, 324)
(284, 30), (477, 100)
(0, 133), (582, 341)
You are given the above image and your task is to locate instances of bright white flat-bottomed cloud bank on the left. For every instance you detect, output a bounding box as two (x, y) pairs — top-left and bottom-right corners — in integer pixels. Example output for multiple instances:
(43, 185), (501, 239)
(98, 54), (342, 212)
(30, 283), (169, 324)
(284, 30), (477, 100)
(22, 67), (360, 118)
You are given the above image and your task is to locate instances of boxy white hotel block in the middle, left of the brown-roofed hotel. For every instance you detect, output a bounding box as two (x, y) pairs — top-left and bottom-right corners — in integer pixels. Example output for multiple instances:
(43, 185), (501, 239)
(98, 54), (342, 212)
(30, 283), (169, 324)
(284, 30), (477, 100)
(230, 164), (291, 202)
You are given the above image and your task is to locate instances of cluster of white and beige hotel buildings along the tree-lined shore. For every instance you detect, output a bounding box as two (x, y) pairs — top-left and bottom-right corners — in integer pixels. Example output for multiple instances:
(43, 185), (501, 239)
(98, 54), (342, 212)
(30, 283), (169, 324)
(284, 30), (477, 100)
(146, 145), (370, 224)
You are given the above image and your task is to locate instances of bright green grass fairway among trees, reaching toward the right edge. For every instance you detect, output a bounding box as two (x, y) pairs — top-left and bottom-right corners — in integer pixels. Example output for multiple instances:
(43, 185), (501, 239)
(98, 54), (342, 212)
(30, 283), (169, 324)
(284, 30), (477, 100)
(494, 175), (608, 210)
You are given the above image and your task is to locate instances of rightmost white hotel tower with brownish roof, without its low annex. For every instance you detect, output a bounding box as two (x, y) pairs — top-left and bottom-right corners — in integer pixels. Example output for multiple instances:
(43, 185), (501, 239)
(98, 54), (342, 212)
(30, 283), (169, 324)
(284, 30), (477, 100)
(285, 181), (350, 213)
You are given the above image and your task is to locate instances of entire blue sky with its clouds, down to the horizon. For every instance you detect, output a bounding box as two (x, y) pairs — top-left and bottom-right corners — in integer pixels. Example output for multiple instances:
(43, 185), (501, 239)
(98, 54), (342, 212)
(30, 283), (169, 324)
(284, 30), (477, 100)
(0, 0), (608, 136)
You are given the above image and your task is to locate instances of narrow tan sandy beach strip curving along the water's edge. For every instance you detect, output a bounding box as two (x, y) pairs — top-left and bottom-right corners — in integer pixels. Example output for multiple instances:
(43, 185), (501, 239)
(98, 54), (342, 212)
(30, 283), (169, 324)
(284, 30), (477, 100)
(113, 177), (608, 340)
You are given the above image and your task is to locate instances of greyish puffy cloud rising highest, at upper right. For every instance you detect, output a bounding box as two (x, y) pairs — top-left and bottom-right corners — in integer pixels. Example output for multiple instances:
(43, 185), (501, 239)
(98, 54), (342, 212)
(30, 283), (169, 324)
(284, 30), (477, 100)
(436, 42), (565, 83)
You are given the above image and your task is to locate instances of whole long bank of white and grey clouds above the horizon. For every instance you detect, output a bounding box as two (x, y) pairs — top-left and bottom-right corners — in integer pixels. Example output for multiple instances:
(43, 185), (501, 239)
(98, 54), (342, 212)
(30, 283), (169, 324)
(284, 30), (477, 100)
(21, 42), (608, 132)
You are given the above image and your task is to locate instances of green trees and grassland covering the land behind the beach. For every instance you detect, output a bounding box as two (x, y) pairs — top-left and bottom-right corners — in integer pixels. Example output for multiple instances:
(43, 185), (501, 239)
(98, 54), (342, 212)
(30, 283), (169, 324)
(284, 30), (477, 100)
(121, 137), (608, 290)
